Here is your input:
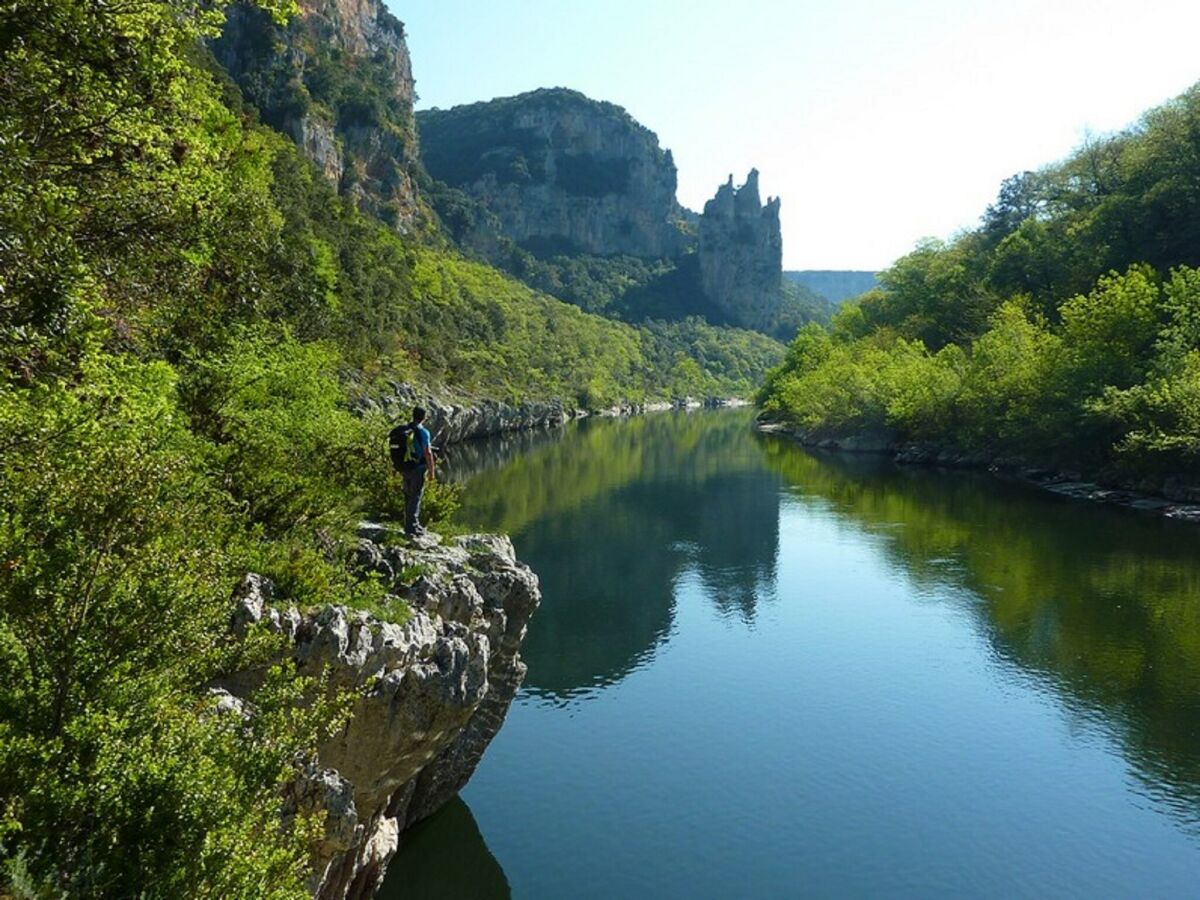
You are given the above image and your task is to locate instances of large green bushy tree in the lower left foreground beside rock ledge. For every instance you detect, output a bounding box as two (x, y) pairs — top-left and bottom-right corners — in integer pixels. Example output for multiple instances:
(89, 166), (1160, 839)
(0, 352), (328, 898)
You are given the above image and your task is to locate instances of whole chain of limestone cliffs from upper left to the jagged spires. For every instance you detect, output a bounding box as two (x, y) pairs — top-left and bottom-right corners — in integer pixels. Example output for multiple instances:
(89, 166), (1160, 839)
(212, 7), (796, 336)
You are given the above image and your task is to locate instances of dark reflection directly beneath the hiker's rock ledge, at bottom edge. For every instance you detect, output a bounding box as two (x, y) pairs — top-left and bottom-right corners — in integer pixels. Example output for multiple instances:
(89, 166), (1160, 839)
(376, 797), (512, 900)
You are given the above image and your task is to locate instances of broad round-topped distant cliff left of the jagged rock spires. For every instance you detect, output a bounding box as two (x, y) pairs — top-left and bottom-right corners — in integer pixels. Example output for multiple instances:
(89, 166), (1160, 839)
(416, 88), (684, 258)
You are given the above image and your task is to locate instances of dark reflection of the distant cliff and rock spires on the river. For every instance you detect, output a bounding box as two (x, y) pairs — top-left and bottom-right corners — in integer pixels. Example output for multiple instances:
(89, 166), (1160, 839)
(451, 412), (779, 698)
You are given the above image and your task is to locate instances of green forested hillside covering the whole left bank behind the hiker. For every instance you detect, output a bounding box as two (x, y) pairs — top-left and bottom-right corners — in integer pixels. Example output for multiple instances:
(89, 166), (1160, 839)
(0, 0), (780, 898)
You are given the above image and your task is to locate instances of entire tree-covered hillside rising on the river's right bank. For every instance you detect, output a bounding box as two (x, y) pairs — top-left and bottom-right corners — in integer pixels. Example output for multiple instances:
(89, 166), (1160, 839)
(760, 86), (1200, 486)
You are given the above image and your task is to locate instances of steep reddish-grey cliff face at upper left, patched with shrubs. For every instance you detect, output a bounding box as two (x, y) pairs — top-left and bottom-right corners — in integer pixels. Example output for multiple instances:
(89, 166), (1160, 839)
(212, 0), (420, 230)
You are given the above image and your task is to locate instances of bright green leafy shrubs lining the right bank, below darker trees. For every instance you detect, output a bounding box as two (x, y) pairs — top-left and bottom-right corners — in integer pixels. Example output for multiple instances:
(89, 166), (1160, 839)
(758, 266), (1200, 472)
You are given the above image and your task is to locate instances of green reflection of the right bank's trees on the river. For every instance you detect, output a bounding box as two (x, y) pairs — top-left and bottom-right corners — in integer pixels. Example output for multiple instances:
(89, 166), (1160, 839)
(762, 438), (1200, 826)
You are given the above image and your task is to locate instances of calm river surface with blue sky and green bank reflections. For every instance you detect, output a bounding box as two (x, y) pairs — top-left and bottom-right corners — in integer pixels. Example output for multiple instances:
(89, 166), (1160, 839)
(384, 412), (1200, 898)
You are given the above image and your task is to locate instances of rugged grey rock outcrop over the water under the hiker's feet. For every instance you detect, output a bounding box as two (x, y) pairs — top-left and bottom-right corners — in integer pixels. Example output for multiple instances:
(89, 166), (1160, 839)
(215, 526), (541, 900)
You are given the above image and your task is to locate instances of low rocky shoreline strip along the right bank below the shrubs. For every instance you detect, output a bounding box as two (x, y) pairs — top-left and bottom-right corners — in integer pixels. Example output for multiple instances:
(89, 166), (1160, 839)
(756, 420), (1200, 522)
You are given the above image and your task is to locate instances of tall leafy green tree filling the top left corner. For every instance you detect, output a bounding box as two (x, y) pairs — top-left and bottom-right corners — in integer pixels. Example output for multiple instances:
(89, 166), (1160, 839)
(0, 0), (296, 373)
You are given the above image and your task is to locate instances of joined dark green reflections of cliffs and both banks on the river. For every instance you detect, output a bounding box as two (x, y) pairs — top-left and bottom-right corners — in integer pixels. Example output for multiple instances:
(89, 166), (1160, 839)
(455, 413), (1200, 822)
